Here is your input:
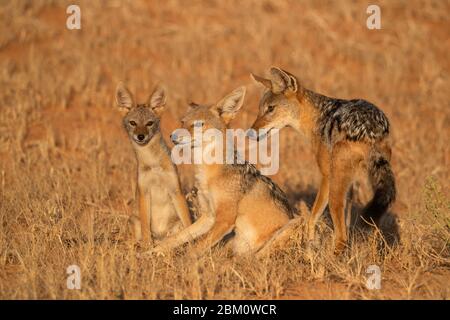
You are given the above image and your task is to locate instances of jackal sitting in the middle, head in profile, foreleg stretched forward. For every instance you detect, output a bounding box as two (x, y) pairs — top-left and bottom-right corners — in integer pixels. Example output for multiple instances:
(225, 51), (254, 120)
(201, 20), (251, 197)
(146, 87), (294, 254)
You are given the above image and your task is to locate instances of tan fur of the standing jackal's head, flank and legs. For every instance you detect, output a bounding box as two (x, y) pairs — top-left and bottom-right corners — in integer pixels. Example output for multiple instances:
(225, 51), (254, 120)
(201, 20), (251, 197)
(252, 68), (390, 253)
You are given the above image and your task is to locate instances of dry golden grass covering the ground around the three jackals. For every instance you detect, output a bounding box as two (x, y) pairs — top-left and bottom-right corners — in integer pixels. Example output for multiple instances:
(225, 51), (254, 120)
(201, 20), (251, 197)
(0, 0), (450, 299)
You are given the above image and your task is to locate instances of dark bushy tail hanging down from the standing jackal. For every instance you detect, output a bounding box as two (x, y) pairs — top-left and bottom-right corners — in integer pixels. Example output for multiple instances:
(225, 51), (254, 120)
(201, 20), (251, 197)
(362, 150), (396, 225)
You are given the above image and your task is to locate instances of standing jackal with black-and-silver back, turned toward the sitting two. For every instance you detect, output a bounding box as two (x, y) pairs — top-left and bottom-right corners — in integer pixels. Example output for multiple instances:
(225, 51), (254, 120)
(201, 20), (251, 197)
(252, 67), (396, 253)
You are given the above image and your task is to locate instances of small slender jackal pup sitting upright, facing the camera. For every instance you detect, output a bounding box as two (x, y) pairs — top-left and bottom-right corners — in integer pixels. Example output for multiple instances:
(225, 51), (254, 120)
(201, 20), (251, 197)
(116, 83), (191, 243)
